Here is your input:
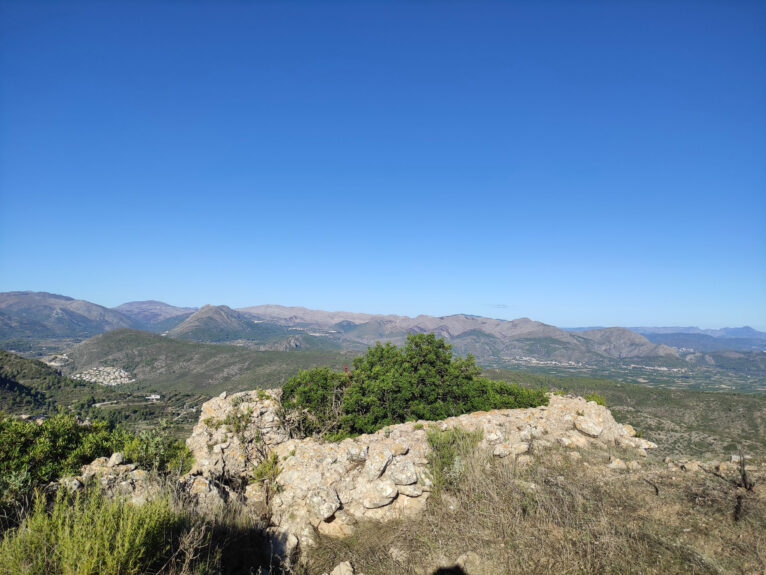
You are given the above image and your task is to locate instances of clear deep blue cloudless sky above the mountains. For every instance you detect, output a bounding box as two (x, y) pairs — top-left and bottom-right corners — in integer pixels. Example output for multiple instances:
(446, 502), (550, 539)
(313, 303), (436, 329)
(0, 0), (766, 329)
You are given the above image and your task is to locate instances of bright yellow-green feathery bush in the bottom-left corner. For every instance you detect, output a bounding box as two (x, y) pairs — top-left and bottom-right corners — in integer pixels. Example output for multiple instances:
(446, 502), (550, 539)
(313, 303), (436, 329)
(0, 489), (183, 575)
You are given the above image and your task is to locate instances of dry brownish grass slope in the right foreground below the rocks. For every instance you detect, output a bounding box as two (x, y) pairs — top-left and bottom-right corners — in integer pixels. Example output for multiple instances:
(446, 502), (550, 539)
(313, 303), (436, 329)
(305, 436), (766, 575)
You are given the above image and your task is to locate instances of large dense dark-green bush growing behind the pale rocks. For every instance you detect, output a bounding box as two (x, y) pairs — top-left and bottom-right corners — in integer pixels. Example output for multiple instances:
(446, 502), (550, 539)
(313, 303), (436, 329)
(282, 334), (548, 437)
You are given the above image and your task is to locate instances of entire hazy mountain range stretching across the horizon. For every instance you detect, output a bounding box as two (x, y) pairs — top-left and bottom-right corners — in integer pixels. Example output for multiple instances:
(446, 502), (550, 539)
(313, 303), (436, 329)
(0, 292), (766, 366)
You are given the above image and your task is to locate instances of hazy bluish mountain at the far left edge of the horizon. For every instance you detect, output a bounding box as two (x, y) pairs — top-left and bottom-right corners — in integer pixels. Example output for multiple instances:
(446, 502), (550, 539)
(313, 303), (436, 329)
(0, 292), (136, 340)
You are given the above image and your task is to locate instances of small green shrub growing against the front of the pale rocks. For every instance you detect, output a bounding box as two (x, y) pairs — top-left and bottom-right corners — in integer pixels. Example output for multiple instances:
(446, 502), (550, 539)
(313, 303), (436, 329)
(426, 427), (482, 490)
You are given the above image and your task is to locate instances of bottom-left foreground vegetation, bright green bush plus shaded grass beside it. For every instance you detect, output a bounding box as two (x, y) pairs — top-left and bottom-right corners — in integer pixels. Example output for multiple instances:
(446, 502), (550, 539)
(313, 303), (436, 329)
(0, 482), (281, 575)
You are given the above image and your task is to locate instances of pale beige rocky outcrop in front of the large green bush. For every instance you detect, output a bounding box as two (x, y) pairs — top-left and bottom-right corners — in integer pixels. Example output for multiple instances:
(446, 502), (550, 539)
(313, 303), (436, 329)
(185, 390), (656, 546)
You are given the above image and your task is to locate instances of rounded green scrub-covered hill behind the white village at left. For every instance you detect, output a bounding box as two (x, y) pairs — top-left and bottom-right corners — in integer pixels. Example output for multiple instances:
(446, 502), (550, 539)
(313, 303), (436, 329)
(66, 330), (350, 396)
